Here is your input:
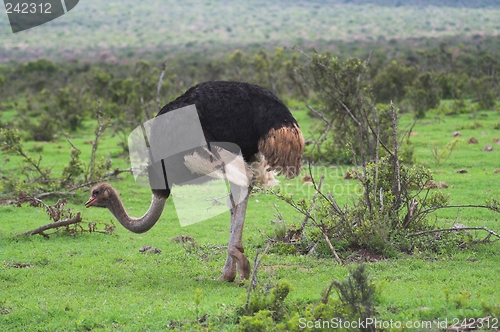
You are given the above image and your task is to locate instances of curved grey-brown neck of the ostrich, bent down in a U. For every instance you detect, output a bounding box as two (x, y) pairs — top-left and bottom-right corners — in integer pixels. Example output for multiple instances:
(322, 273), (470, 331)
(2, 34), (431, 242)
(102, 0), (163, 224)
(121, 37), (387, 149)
(108, 195), (166, 233)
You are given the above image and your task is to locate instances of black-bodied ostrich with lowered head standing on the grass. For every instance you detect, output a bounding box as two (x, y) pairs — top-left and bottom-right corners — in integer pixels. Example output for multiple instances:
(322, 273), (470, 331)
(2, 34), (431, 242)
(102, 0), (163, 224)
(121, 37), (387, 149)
(85, 81), (304, 281)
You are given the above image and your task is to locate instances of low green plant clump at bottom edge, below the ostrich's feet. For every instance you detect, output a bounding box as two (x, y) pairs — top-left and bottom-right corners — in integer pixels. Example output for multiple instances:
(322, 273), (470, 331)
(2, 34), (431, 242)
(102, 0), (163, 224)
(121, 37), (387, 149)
(236, 264), (381, 332)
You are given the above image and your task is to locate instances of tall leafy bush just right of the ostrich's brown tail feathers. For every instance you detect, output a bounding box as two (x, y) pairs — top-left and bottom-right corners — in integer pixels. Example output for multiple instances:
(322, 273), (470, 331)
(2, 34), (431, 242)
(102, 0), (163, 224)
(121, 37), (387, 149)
(300, 52), (392, 164)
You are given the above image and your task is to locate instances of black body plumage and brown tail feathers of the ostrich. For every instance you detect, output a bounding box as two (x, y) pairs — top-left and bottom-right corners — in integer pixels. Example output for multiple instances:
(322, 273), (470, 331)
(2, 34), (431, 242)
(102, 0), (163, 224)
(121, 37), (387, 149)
(150, 81), (304, 197)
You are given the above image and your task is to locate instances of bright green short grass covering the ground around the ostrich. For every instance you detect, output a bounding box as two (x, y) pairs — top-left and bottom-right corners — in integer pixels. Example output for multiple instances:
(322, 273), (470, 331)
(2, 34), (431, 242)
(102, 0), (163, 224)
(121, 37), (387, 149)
(0, 104), (500, 331)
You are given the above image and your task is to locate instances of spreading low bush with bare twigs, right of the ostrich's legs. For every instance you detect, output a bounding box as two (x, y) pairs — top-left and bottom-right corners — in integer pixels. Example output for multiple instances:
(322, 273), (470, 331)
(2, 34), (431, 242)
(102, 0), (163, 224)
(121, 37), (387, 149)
(277, 156), (454, 257)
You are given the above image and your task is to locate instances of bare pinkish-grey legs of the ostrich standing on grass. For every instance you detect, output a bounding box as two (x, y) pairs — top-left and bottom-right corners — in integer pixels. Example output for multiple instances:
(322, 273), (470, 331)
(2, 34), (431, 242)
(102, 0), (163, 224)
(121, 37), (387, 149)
(219, 188), (252, 282)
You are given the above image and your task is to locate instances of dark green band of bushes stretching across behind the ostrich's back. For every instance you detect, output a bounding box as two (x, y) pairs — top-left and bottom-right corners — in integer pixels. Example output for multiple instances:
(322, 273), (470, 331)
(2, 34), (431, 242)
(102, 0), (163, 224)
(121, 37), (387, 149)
(0, 38), (500, 162)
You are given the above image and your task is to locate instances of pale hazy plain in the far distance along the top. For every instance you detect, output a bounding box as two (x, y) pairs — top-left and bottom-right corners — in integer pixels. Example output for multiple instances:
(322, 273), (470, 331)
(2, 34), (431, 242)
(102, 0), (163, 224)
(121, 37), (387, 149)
(0, 0), (500, 62)
